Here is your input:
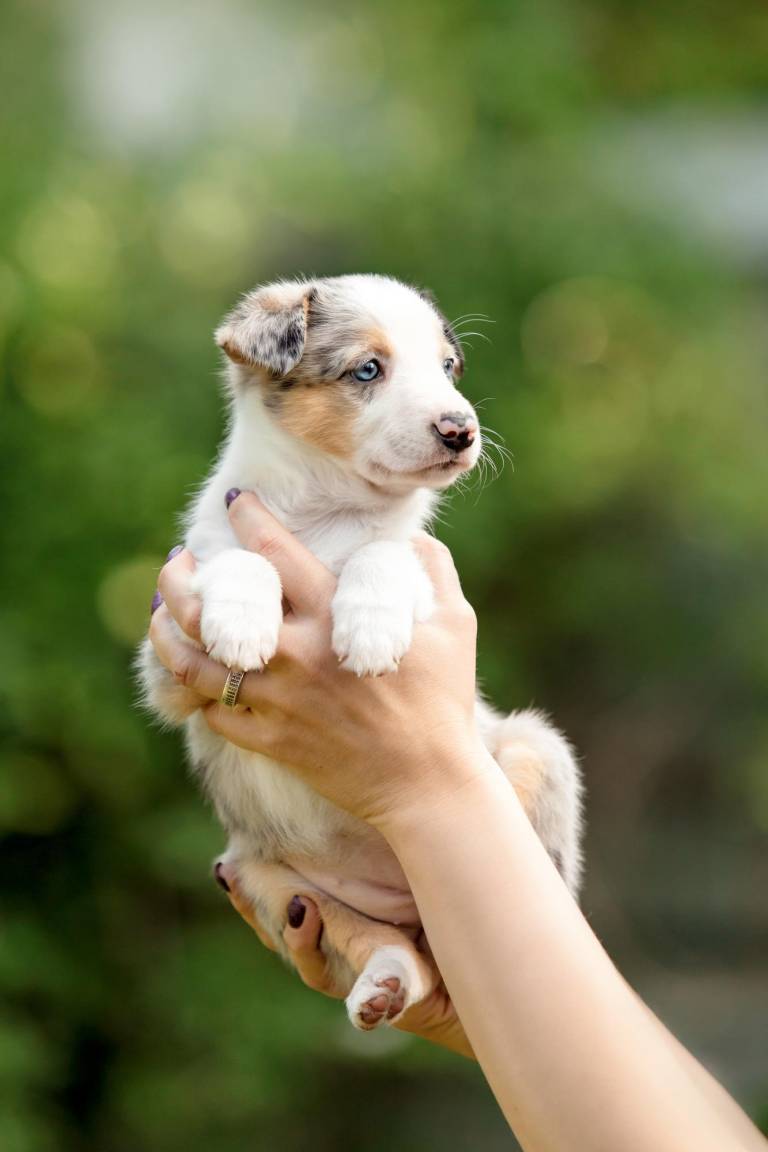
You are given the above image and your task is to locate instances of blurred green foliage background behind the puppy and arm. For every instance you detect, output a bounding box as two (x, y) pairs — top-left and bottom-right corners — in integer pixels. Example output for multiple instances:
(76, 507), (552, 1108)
(0, 0), (768, 1152)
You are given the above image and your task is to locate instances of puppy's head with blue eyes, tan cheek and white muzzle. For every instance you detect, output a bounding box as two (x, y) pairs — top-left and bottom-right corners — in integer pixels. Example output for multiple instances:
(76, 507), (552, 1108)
(216, 275), (480, 492)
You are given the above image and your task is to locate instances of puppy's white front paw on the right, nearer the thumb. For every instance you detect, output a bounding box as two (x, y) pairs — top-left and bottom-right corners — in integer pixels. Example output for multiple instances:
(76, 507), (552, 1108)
(332, 599), (413, 676)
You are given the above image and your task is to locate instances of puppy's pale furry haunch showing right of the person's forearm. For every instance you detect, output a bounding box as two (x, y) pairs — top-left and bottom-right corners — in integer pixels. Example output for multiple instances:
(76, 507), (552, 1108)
(478, 702), (581, 895)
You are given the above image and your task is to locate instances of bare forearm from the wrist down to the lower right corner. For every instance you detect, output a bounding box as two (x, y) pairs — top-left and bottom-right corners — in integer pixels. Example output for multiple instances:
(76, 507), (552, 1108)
(385, 753), (759, 1152)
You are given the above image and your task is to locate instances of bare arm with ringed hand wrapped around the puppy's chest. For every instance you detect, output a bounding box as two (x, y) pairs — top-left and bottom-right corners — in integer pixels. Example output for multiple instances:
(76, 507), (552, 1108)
(147, 497), (765, 1152)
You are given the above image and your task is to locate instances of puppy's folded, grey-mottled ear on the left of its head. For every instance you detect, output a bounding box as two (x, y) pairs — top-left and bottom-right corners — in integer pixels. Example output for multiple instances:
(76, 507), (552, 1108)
(214, 281), (314, 376)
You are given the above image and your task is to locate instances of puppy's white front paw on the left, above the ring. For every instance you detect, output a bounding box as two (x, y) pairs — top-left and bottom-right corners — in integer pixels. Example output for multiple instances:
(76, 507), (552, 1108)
(195, 550), (282, 672)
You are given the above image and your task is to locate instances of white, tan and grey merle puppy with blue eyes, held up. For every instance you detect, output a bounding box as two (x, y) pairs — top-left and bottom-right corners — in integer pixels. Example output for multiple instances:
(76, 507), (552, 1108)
(139, 275), (580, 1030)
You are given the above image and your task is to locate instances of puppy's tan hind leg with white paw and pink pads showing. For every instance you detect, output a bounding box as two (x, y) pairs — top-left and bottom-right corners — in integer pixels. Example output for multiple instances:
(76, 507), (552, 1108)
(227, 854), (439, 1031)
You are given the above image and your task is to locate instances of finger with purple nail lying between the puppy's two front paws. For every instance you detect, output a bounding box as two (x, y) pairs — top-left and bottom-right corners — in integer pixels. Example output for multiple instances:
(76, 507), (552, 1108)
(229, 492), (336, 613)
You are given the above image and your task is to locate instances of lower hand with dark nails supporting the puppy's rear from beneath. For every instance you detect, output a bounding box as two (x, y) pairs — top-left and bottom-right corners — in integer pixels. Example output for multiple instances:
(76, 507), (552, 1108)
(216, 863), (474, 1060)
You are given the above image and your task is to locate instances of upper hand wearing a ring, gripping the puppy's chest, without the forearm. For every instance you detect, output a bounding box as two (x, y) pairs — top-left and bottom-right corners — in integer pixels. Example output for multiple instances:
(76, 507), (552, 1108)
(150, 493), (499, 835)
